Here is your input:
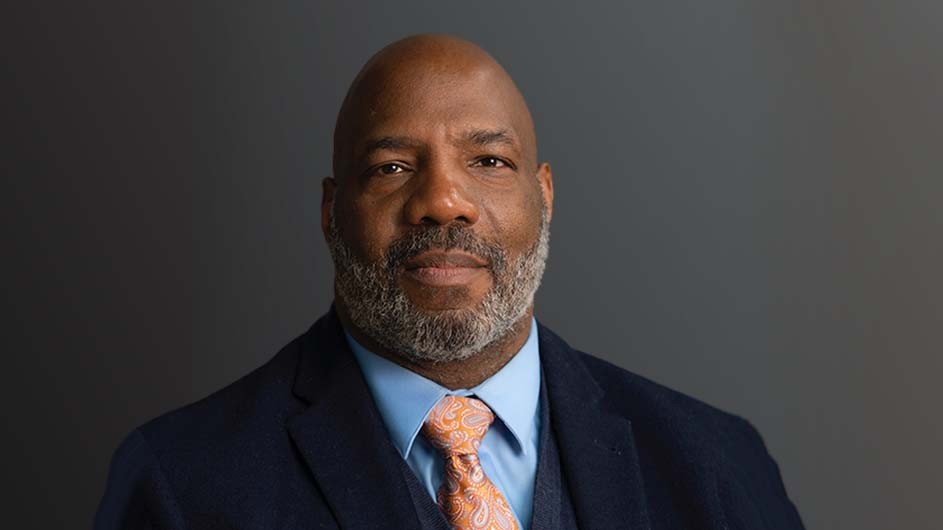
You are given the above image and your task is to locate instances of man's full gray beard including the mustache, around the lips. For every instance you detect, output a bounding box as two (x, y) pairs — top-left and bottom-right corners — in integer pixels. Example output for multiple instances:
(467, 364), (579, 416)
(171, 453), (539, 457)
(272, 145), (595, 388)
(328, 200), (550, 363)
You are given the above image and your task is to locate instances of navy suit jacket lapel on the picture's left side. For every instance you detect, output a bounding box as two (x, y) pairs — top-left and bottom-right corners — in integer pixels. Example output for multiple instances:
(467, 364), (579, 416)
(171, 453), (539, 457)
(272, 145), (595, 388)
(288, 306), (419, 528)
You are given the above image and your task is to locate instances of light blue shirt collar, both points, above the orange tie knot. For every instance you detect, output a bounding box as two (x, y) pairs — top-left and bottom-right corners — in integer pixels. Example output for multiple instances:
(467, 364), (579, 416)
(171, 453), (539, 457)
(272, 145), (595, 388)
(344, 317), (540, 458)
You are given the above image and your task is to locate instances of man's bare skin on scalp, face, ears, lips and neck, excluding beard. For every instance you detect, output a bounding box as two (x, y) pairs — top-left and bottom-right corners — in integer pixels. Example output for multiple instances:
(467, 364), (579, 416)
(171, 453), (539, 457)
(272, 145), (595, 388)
(321, 35), (553, 390)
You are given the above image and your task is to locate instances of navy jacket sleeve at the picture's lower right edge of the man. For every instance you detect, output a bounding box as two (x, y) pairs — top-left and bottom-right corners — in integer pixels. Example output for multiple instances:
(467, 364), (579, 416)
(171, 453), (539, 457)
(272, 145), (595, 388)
(719, 417), (804, 530)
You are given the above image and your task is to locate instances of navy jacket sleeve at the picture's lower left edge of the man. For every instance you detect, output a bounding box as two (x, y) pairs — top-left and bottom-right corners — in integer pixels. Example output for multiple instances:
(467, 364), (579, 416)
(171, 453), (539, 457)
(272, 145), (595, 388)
(94, 430), (185, 530)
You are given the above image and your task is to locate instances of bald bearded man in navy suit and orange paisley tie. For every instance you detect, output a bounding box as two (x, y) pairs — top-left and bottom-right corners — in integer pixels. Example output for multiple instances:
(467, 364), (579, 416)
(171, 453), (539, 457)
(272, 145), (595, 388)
(96, 35), (802, 530)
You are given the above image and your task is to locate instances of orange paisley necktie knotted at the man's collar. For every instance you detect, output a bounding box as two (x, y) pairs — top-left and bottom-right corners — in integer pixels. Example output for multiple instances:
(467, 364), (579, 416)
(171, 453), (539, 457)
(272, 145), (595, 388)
(422, 396), (520, 530)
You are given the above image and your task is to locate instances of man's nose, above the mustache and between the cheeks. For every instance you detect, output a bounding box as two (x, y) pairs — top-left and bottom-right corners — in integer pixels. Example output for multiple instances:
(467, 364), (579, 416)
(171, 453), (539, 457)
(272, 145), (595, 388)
(405, 159), (478, 225)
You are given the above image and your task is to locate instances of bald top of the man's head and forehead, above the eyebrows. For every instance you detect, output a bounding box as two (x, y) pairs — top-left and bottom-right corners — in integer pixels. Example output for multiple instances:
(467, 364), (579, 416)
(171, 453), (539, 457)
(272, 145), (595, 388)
(333, 34), (537, 180)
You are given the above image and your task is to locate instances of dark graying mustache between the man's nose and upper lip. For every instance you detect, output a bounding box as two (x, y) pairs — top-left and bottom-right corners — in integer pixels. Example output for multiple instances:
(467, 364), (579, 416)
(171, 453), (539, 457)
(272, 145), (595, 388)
(386, 224), (507, 275)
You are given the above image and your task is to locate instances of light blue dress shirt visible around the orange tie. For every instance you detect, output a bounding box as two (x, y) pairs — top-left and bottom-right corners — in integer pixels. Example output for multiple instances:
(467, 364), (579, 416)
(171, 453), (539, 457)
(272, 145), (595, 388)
(344, 318), (540, 529)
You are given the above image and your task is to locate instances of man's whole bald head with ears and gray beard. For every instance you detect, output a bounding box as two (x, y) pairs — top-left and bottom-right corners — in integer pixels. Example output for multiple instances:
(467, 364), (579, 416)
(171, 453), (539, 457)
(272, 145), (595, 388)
(321, 35), (553, 362)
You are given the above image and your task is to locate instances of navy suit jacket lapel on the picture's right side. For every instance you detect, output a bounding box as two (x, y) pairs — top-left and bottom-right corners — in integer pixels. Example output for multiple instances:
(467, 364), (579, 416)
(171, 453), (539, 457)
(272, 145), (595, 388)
(538, 322), (650, 530)
